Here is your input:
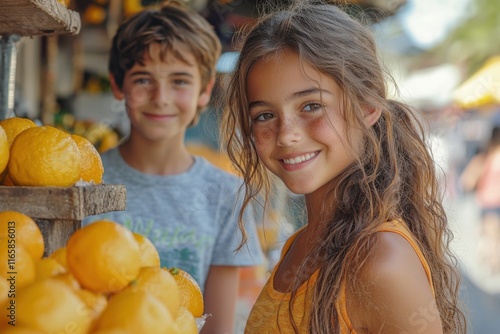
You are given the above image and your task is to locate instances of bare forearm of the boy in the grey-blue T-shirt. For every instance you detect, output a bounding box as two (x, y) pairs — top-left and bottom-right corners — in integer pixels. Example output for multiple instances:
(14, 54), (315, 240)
(201, 265), (240, 334)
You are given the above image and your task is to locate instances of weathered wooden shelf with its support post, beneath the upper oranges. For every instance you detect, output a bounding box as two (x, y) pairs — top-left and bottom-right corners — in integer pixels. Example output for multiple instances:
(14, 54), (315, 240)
(0, 184), (126, 256)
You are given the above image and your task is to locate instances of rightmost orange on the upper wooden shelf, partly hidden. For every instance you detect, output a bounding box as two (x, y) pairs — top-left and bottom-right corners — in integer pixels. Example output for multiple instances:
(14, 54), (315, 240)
(71, 134), (104, 184)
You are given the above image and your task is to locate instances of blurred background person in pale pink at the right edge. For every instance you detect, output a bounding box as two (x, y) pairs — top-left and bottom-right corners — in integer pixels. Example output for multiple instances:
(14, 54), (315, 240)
(460, 126), (500, 273)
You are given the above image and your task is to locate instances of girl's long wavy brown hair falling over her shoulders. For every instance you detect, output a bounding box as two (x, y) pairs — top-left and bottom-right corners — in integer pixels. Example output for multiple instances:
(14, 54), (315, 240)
(221, 1), (466, 333)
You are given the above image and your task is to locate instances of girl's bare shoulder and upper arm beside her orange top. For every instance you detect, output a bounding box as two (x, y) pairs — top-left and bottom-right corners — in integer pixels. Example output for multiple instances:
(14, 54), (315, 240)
(347, 232), (442, 334)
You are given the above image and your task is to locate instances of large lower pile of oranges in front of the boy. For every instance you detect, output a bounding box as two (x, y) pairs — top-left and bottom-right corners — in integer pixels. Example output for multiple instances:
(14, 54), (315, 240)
(0, 211), (204, 334)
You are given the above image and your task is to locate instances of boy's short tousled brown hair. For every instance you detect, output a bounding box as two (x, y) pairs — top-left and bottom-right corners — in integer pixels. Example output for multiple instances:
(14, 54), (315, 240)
(108, 1), (221, 89)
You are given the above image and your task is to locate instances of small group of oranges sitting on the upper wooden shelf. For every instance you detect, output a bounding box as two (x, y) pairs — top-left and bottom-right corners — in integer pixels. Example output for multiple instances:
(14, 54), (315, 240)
(0, 117), (104, 187)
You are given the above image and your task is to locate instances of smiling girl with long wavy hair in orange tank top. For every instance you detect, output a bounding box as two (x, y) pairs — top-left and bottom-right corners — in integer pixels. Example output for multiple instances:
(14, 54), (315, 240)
(222, 1), (465, 334)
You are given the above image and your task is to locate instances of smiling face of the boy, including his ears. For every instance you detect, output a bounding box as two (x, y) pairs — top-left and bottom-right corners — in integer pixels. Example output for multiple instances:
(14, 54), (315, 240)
(111, 44), (212, 142)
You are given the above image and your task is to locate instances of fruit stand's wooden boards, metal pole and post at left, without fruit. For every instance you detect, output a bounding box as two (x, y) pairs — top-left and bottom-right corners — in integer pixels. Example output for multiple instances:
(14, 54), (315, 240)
(0, 0), (126, 256)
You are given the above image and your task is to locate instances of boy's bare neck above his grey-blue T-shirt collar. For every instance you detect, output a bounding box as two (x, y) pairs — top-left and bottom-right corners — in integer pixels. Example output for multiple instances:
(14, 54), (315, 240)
(119, 139), (194, 175)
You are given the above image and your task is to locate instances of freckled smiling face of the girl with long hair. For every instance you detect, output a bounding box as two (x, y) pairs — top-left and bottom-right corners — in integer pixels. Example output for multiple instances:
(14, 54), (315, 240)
(247, 51), (362, 194)
